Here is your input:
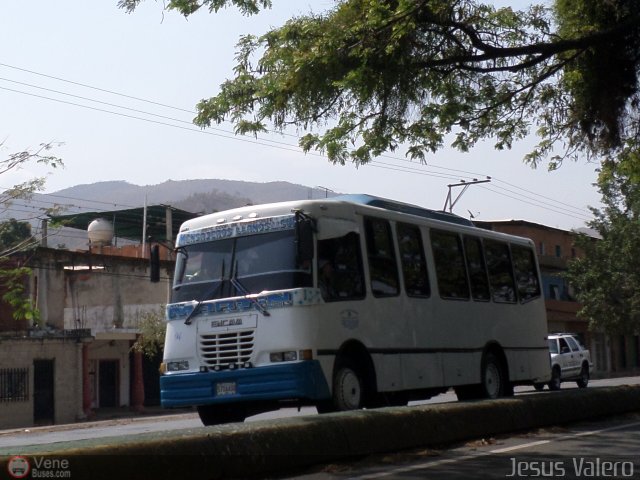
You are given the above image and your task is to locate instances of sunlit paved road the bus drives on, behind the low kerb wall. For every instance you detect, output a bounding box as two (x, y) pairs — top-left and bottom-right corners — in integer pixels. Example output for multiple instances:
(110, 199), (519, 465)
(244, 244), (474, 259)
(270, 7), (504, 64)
(0, 377), (640, 455)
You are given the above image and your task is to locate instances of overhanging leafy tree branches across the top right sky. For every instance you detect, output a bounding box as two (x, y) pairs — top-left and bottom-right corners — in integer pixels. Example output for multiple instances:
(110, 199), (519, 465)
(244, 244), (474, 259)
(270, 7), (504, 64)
(120, 0), (640, 168)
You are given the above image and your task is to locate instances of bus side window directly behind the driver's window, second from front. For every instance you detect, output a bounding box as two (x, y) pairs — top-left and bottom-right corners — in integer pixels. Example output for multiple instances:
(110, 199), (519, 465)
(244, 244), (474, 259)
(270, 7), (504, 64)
(364, 217), (400, 297)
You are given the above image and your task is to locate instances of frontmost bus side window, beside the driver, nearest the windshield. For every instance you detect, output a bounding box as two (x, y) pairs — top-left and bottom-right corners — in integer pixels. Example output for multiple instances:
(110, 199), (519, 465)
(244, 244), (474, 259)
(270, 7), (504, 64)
(318, 232), (364, 302)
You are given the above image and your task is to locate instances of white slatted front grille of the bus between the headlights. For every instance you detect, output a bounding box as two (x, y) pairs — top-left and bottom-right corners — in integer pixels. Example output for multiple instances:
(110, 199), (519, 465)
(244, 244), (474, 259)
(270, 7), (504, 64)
(200, 330), (254, 368)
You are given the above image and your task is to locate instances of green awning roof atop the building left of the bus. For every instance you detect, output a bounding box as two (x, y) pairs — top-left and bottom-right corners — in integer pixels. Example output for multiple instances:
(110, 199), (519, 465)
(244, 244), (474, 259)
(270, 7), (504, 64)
(49, 205), (199, 243)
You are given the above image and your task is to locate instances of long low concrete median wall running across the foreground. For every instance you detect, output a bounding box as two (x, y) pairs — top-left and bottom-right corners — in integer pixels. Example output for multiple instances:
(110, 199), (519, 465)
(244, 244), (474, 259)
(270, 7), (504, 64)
(0, 386), (640, 480)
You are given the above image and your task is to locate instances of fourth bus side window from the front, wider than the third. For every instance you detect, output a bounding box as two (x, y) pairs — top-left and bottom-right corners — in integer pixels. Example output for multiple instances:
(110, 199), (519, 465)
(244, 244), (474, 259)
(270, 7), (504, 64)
(431, 230), (469, 300)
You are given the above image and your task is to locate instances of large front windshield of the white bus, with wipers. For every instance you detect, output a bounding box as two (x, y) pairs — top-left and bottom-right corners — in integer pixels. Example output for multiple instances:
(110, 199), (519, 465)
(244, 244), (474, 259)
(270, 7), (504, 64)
(171, 230), (313, 303)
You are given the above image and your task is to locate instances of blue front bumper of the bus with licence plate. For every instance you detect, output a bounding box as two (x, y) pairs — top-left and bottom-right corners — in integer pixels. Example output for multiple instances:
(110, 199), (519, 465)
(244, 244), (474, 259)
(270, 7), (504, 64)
(160, 360), (330, 408)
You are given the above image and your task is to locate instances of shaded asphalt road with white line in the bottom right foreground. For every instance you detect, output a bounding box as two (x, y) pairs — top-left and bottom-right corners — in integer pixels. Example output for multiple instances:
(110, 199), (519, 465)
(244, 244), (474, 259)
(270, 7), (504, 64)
(281, 408), (640, 480)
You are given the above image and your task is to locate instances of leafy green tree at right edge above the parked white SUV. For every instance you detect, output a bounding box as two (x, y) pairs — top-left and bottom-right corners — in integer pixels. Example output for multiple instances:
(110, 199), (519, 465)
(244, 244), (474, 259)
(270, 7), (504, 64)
(567, 144), (640, 335)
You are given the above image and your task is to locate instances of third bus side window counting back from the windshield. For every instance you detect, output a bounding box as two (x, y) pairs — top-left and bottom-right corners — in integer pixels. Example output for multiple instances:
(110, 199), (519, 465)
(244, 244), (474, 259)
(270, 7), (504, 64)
(396, 223), (431, 297)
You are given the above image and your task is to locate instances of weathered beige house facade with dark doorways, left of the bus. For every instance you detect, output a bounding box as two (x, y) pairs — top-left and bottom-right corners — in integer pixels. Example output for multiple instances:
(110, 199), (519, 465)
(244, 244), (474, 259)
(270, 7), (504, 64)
(0, 246), (173, 428)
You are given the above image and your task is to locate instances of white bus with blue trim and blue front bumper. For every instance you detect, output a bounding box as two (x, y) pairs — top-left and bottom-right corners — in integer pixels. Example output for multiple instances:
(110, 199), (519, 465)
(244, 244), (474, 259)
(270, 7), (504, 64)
(160, 195), (550, 425)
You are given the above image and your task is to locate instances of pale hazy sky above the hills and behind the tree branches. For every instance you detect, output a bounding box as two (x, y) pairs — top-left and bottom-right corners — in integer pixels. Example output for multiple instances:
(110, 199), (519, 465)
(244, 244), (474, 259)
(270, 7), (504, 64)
(0, 0), (599, 229)
